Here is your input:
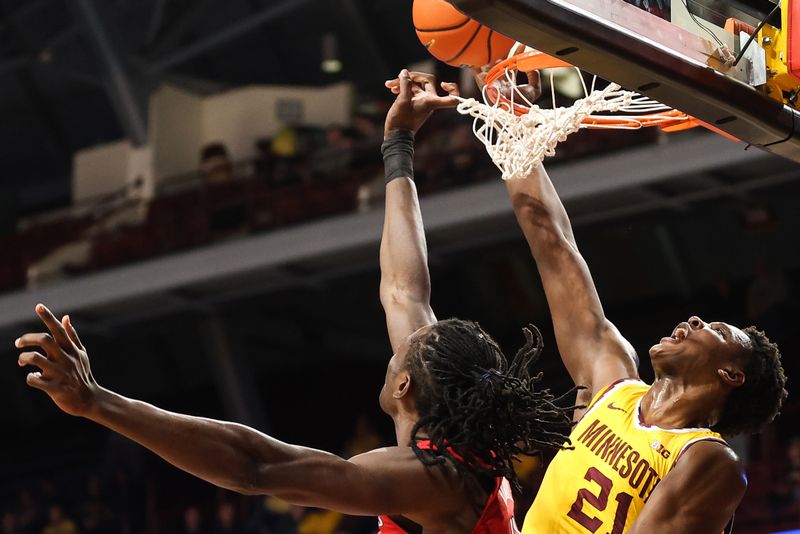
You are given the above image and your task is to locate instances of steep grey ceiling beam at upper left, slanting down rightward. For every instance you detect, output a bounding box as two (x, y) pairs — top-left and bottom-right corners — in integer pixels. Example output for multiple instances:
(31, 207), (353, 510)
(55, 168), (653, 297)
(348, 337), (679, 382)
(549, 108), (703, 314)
(68, 0), (147, 146)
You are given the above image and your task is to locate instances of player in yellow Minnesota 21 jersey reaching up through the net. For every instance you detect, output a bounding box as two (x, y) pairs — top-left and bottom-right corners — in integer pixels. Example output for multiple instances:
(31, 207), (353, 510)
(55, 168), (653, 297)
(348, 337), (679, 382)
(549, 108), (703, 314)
(506, 158), (786, 534)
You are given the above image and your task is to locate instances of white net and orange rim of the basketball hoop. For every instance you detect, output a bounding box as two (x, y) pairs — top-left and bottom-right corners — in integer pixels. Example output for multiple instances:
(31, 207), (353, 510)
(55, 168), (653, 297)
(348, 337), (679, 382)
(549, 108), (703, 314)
(457, 48), (696, 180)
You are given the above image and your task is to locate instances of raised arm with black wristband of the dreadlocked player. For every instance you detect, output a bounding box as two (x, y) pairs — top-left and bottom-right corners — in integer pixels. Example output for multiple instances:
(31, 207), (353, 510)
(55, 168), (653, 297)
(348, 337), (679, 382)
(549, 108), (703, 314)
(380, 70), (456, 351)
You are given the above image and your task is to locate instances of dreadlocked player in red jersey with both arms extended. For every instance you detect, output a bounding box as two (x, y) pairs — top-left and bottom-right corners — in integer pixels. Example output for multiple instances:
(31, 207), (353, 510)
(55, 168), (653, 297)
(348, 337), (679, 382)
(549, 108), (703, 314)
(15, 71), (569, 534)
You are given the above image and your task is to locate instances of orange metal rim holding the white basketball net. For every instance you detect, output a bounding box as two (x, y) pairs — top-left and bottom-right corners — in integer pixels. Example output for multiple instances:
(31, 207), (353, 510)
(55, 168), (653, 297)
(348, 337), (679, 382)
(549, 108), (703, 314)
(485, 50), (700, 132)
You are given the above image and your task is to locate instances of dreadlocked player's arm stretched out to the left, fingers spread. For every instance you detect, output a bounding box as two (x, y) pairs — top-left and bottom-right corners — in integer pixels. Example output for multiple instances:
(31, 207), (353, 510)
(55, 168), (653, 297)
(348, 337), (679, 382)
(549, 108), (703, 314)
(16, 305), (453, 515)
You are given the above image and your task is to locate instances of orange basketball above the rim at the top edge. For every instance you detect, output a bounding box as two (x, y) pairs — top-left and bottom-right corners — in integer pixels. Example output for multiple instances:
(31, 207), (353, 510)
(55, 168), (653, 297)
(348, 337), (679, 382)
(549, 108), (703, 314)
(412, 0), (514, 67)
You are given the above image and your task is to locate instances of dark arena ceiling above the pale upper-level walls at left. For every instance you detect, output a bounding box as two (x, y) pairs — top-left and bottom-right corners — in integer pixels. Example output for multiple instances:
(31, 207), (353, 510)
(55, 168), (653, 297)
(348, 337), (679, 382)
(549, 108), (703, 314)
(0, 0), (426, 224)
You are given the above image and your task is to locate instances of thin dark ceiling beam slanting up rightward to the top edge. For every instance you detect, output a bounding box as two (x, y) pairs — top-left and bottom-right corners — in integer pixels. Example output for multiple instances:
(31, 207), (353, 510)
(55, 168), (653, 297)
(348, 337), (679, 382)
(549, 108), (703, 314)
(148, 0), (311, 74)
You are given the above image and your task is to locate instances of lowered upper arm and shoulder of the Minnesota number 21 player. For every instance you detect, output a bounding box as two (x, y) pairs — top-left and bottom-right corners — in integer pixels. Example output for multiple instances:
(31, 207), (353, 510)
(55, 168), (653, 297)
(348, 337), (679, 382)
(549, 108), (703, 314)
(629, 441), (747, 534)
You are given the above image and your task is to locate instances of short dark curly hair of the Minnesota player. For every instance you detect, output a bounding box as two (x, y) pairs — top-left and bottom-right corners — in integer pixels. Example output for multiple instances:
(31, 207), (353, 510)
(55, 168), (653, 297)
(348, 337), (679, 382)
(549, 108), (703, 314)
(711, 326), (788, 436)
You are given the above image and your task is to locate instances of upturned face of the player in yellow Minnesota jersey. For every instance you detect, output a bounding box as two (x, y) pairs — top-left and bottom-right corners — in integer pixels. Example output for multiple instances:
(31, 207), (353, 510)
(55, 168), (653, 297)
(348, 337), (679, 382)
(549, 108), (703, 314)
(650, 316), (750, 379)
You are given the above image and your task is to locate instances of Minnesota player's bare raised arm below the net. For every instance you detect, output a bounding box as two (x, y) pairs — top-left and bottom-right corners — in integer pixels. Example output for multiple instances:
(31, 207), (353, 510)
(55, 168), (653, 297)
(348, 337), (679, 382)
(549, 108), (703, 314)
(506, 165), (638, 400)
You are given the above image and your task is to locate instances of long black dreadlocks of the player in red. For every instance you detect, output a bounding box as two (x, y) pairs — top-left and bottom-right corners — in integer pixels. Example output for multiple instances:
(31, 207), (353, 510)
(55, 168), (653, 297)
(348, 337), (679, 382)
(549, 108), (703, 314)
(408, 319), (575, 488)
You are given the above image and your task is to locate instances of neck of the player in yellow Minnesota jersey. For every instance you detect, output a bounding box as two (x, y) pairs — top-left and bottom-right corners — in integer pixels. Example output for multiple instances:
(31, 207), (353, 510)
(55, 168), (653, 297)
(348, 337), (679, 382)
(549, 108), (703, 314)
(640, 376), (721, 429)
